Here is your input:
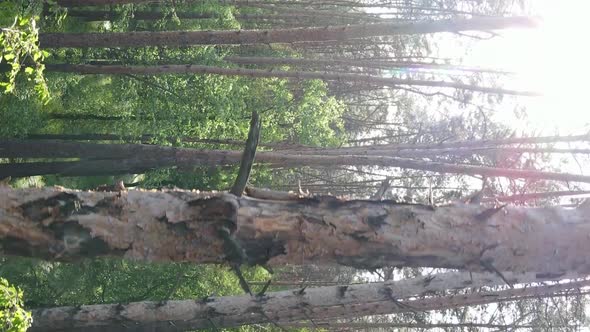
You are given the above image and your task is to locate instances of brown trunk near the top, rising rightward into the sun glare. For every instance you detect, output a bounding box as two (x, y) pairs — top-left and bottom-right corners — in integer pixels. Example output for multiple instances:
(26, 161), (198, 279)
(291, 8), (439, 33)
(39, 17), (536, 48)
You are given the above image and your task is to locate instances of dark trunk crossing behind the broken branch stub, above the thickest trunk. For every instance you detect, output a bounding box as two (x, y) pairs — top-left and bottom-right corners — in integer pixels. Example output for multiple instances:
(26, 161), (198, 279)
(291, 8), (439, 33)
(0, 139), (590, 183)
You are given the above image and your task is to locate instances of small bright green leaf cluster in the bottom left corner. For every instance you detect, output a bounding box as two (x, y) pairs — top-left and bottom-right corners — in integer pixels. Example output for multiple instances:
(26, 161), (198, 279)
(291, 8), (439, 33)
(0, 278), (33, 332)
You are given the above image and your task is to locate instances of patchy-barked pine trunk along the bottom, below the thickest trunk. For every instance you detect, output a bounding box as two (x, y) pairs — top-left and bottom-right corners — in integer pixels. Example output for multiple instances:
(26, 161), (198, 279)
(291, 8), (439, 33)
(30, 276), (590, 332)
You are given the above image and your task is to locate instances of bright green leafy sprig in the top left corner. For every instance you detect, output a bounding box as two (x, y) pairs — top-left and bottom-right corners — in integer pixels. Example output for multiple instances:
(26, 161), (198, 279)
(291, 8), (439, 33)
(0, 1), (49, 103)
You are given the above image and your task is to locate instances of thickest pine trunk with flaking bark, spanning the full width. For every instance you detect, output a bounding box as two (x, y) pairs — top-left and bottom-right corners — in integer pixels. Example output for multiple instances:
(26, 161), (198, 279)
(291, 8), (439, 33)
(0, 187), (590, 274)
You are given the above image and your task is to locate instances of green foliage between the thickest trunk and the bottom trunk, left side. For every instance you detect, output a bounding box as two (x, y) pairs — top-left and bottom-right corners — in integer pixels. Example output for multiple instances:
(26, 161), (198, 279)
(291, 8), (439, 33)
(0, 258), (268, 307)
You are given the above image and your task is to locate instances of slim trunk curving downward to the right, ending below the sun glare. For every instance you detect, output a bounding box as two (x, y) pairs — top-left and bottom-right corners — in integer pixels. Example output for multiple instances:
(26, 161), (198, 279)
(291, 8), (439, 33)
(45, 64), (539, 96)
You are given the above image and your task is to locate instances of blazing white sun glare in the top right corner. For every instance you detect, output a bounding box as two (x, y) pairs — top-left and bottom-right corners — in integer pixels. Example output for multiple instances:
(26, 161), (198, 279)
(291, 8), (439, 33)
(466, 0), (590, 134)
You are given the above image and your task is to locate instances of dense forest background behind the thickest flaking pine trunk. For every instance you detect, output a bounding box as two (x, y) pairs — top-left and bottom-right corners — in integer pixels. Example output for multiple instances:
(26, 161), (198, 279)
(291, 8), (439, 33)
(0, 0), (590, 331)
